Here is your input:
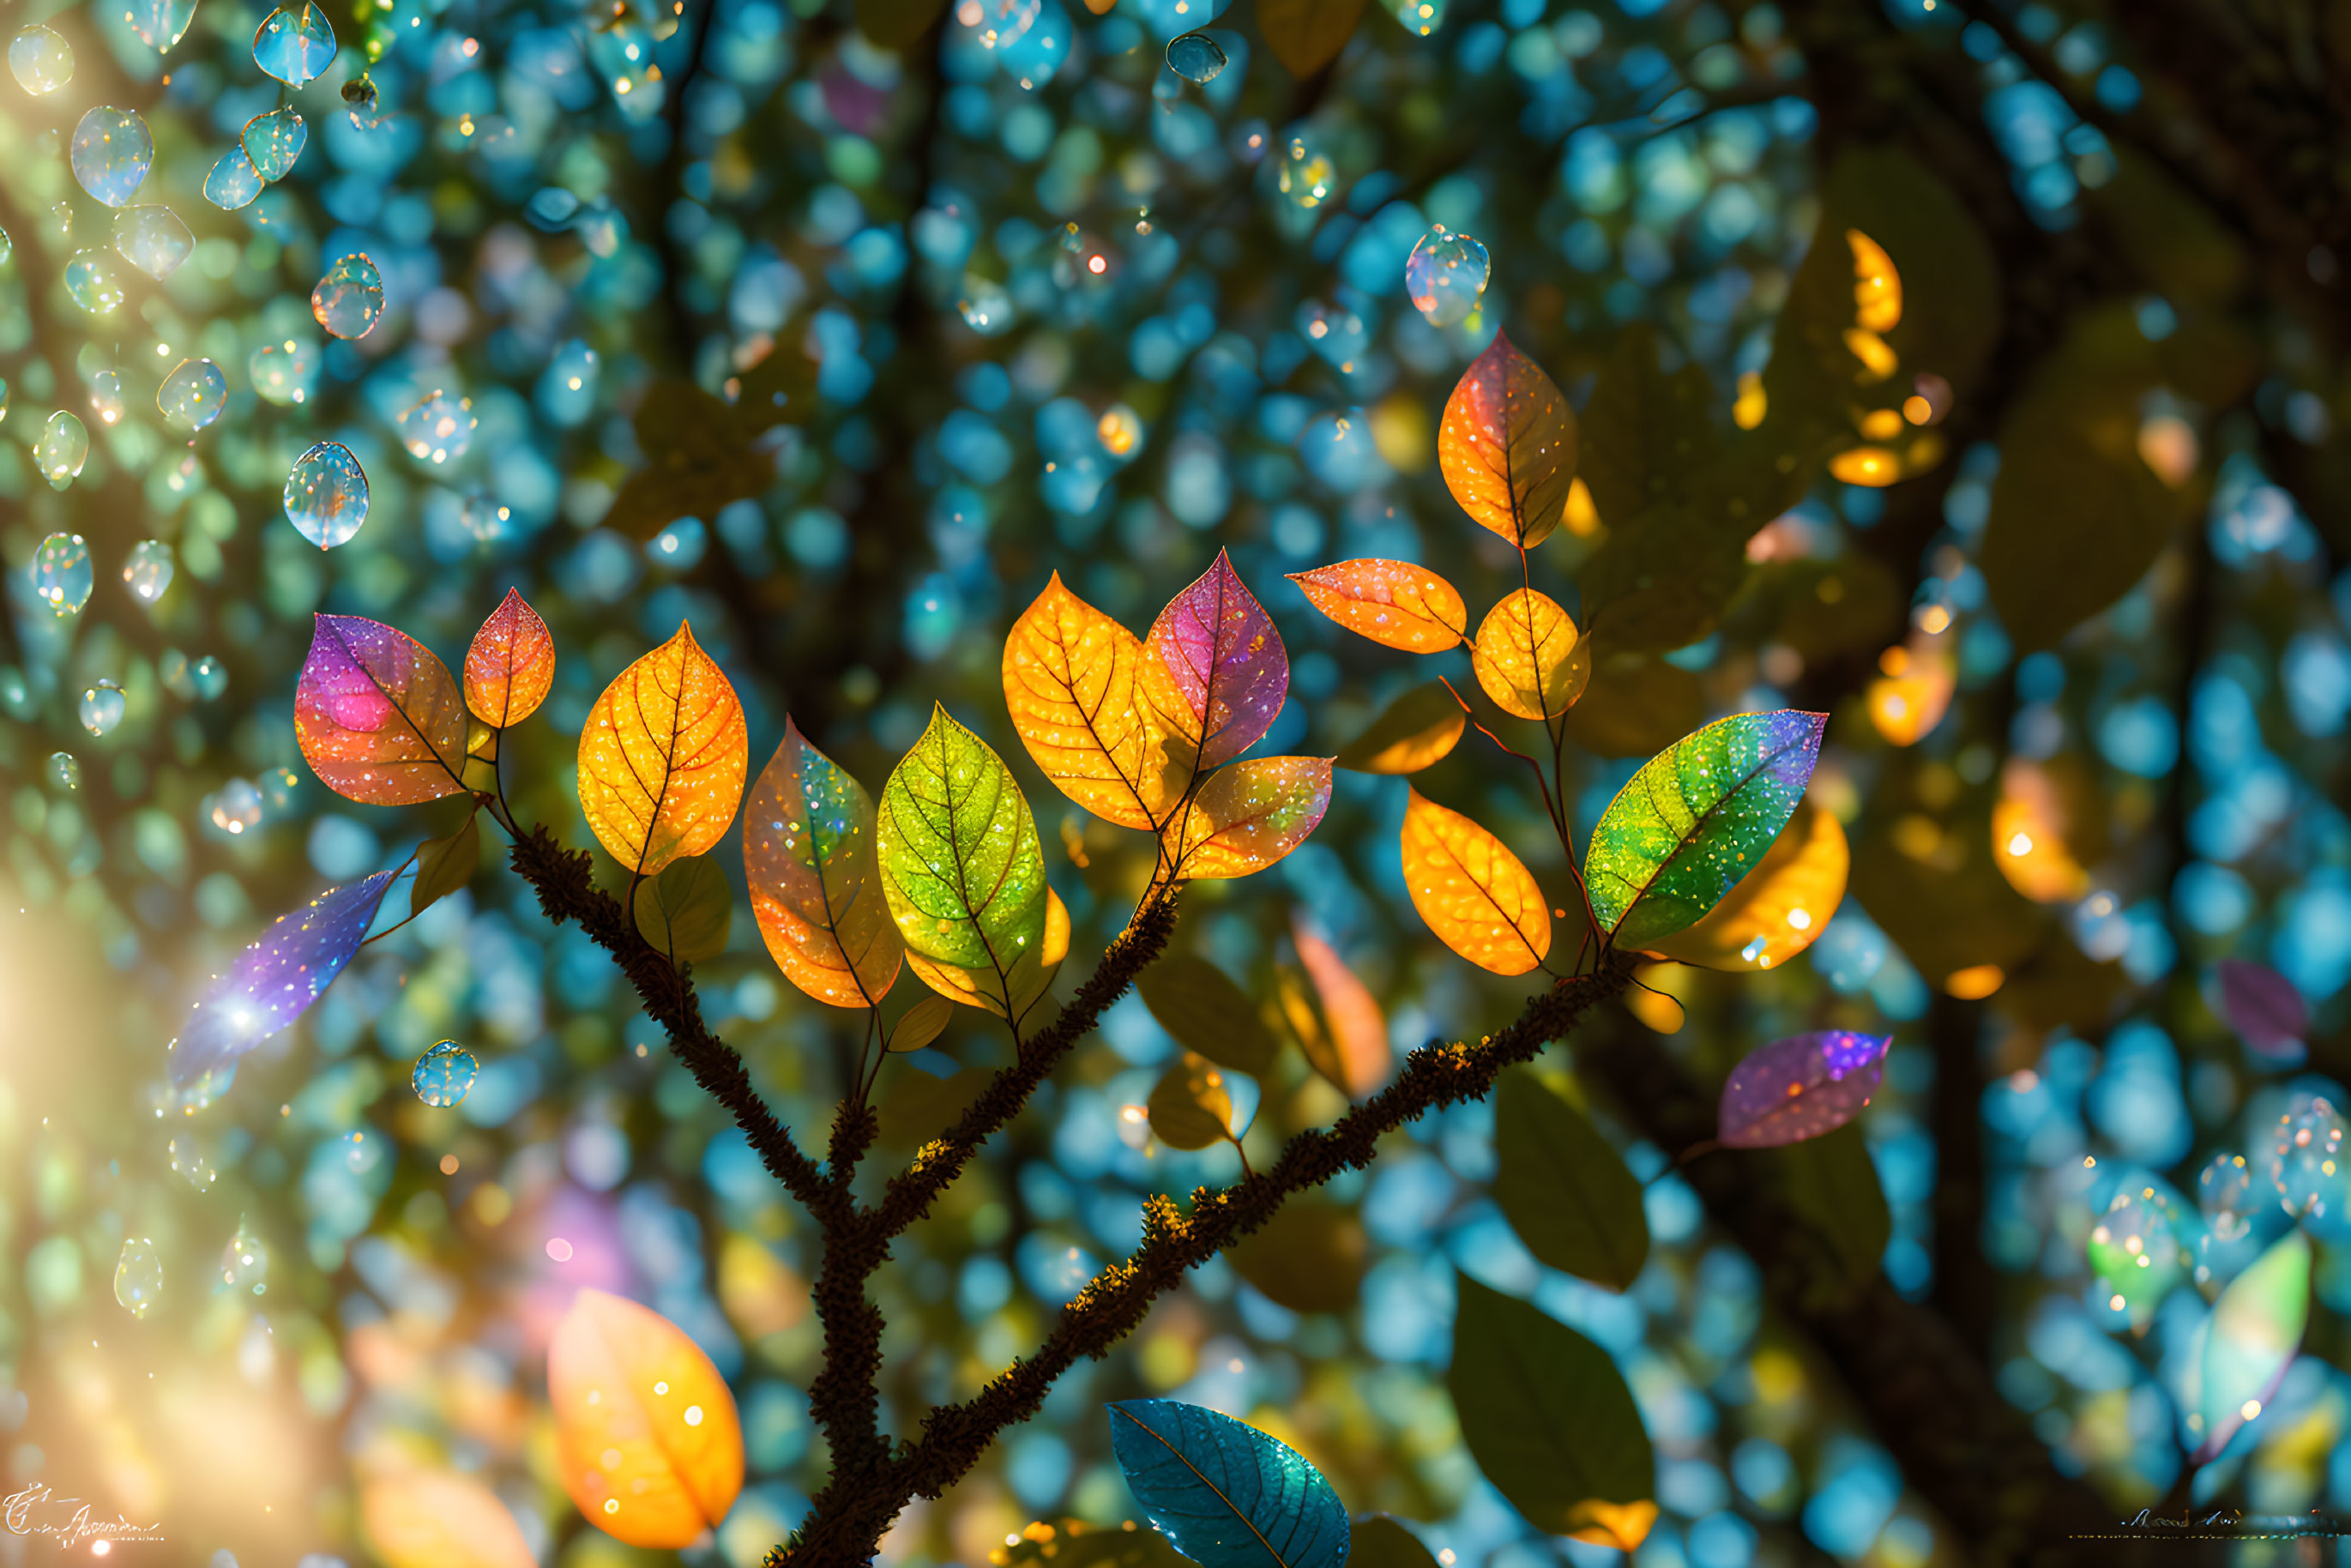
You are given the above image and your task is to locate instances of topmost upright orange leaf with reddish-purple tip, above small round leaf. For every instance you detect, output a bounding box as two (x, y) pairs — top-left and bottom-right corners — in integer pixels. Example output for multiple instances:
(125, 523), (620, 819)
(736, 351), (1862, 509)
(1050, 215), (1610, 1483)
(1437, 334), (1575, 550)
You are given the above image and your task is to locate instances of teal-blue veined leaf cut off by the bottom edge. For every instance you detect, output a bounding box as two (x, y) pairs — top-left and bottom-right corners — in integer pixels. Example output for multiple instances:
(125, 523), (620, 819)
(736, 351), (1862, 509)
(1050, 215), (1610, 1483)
(1110, 1399), (1347, 1568)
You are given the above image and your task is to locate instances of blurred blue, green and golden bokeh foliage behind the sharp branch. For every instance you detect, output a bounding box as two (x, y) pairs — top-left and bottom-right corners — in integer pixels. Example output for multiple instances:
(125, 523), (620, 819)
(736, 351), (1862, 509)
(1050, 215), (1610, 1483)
(0, 0), (2351, 1568)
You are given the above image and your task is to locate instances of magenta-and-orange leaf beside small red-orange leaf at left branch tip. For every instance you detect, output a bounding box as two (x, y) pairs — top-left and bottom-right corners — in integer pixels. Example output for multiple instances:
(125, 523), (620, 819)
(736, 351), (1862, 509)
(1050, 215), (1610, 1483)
(294, 616), (466, 806)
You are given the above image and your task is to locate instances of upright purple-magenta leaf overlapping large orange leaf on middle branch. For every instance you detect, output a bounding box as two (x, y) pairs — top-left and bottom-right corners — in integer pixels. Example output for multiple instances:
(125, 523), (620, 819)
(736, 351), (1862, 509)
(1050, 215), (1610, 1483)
(1142, 550), (1291, 769)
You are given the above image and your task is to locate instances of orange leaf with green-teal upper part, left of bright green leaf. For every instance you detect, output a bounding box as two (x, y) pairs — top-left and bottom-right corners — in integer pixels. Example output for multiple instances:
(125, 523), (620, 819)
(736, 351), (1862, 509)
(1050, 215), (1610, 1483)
(743, 717), (902, 1005)
